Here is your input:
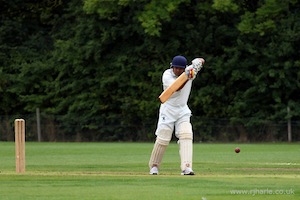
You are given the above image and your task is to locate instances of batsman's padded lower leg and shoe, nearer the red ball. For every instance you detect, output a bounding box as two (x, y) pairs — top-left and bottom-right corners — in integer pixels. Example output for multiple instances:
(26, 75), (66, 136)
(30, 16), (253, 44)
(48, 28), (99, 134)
(176, 120), (194, 175)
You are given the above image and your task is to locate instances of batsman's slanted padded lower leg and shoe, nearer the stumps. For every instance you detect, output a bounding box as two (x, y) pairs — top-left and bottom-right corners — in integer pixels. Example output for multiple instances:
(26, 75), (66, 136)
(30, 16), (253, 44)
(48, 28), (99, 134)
(149, 126), (173, 175)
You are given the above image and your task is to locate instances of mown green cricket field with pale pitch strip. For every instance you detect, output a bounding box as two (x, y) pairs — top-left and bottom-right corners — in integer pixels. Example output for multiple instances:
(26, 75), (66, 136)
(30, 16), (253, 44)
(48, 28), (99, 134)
(0, 142), (300, 200)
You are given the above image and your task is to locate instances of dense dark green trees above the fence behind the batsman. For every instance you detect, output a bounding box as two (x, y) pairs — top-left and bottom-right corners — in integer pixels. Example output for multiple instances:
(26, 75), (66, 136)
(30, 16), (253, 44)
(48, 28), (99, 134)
(0, 0), (300, 141)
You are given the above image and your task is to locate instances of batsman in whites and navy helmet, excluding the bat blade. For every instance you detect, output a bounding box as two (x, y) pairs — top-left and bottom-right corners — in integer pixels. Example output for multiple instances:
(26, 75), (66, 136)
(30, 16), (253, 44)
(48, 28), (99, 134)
(149, 55), (204, 175)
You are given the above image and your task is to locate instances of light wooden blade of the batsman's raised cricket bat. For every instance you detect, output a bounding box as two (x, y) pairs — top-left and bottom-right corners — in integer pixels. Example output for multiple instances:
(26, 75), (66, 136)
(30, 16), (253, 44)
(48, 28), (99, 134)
(158, 72), (188, 103)
